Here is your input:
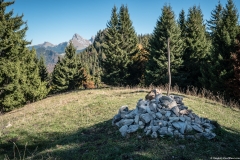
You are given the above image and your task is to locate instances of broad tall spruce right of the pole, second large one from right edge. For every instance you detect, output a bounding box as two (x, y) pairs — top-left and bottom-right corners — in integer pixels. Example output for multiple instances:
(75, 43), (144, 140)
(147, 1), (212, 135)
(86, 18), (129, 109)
(183, 6), (210, 87)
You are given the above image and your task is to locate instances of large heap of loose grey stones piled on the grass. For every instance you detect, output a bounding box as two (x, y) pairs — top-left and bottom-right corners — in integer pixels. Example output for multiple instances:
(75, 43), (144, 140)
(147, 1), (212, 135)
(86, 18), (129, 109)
(112, 89), (216, 139)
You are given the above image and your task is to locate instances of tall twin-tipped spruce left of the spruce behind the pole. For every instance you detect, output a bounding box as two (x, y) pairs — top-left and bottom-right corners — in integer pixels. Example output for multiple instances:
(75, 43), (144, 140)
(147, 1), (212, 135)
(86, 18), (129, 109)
(102, 5), (137, 85)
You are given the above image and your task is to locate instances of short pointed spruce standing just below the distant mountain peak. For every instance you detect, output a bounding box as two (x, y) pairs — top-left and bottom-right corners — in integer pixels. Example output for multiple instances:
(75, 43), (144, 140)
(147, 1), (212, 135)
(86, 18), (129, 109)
(52, 41), (86, 93)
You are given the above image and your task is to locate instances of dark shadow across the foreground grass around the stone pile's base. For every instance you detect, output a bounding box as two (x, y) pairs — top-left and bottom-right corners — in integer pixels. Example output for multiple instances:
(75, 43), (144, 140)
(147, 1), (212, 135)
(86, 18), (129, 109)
(0, 120), (240, 160)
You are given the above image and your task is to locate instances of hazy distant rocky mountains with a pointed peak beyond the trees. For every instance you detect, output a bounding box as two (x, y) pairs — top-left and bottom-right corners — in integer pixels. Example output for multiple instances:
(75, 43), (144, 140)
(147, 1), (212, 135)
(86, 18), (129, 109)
(29, 33), (94, 73)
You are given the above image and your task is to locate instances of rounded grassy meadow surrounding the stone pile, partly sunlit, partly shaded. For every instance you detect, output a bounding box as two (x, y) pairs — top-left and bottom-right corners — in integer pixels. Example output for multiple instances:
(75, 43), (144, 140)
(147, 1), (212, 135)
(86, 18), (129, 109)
(0, 88), (240, 160)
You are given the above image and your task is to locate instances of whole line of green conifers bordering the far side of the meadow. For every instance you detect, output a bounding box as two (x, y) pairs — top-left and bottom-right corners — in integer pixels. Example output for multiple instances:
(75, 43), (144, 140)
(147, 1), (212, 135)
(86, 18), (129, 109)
(0, 0), (240, 111)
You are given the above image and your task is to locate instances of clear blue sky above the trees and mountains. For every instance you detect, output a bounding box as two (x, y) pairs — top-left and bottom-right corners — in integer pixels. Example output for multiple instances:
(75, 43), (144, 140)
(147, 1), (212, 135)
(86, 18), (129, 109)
(7, 0), (240, 45)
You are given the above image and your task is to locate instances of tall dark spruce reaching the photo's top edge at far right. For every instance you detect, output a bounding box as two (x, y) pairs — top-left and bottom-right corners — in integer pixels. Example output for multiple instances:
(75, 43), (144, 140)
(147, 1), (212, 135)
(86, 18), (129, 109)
(202, 0), (239, 95)
